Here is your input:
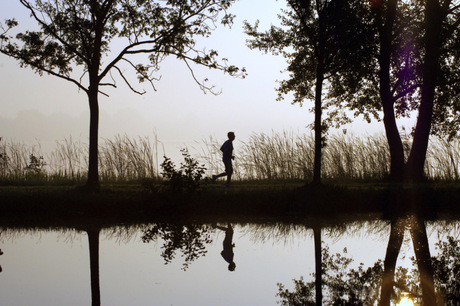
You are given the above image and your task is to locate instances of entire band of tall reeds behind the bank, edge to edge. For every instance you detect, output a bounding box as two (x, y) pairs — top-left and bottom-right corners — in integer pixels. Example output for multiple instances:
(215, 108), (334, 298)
(0, 131), (460, 184)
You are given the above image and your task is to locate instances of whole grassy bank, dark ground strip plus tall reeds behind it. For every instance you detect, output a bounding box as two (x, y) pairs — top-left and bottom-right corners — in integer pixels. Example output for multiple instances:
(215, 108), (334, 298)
(0, 132), (460, 225)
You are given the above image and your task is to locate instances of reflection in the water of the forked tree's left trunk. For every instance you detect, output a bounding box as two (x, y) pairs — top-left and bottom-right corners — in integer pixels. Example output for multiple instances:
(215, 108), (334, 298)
(379, 219), (406, 306)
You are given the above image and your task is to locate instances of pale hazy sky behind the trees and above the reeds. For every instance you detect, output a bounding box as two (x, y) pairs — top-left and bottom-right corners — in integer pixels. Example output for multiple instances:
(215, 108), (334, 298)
(0, 0), (414, 157)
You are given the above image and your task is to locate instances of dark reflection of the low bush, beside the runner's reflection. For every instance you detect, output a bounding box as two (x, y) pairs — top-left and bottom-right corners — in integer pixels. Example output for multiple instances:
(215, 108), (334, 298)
(142, 223), (214, 270)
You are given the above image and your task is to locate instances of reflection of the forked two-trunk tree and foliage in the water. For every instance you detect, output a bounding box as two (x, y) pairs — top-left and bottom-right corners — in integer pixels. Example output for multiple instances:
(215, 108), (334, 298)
(277, 216), (460, 305)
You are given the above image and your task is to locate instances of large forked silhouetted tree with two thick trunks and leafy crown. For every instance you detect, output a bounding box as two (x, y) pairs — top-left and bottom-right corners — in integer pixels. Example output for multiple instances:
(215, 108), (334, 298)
(341, 0), (460, 180)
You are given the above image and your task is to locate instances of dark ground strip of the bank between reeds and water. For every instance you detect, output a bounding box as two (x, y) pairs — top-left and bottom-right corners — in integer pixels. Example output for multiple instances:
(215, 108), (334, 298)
(0, 181), (460, 226)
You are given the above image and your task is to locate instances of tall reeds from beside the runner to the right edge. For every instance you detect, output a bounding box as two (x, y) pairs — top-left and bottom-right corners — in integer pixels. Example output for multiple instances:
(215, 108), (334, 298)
(194, 131), (460, 181)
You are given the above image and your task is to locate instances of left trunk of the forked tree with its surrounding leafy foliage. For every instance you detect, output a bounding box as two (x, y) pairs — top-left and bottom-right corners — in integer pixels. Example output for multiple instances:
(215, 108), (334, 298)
(331, 0), (420, 180)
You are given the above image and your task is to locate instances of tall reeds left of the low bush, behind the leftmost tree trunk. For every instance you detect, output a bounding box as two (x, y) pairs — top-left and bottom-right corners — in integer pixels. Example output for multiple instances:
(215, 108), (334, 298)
(0, 135), (163, 184)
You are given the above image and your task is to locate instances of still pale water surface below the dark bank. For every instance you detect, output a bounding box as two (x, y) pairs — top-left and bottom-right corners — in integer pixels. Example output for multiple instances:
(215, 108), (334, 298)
(0, 221), (458, 306)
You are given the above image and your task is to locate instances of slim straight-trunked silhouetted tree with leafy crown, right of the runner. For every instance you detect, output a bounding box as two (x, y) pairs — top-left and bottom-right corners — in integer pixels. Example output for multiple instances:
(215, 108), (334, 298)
(245, 0), (365, 184)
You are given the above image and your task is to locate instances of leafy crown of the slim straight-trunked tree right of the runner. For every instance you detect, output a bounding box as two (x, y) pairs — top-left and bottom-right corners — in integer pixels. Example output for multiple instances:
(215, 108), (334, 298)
(245, 0), (370, 128)
